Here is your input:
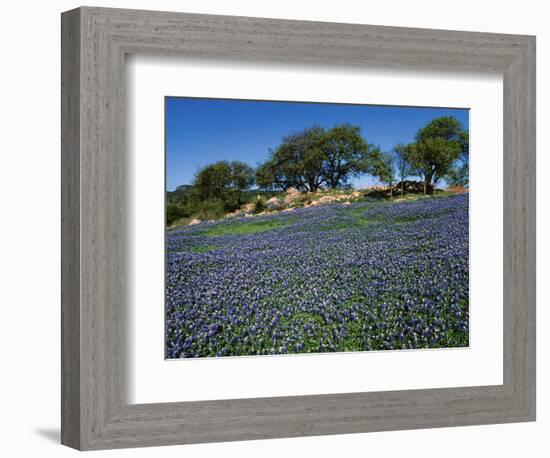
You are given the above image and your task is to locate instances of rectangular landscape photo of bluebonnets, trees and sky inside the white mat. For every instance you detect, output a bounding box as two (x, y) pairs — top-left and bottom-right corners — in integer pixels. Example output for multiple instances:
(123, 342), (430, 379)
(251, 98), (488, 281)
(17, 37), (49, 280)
(165, 97), (470, 359)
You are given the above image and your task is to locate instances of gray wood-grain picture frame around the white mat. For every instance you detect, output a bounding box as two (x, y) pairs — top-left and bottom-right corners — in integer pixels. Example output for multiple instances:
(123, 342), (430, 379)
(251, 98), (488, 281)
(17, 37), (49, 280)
(61, 7), (535, 450)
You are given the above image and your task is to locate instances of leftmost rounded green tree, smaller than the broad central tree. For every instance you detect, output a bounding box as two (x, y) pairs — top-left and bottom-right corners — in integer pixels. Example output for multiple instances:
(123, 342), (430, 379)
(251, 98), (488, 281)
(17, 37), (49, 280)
(192, 161), (254, 211)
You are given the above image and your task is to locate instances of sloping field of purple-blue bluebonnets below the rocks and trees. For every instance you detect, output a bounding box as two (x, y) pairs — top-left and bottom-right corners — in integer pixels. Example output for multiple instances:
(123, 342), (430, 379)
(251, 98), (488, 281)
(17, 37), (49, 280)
(166, 194), (469, 358)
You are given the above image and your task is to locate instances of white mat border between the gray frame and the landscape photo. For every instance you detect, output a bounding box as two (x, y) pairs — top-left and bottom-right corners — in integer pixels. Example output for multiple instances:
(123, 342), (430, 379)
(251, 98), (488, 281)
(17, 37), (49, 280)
(127, 56), (503, 403)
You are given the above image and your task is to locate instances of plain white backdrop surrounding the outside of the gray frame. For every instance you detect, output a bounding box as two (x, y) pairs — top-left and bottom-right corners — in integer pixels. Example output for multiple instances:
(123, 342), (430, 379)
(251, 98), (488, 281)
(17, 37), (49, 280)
(0, 0), (550, 458)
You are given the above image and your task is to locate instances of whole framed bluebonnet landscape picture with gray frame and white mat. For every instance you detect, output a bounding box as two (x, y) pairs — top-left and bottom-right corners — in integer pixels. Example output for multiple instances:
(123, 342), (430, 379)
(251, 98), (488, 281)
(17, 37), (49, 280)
(62, 7), (535, 450)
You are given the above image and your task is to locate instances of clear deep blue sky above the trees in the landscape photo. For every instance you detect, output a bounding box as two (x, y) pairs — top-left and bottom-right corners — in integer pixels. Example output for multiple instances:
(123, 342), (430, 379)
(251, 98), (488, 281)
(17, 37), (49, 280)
(165, 97), (468, 191)
